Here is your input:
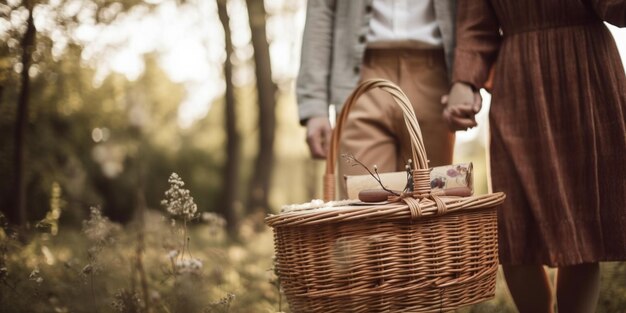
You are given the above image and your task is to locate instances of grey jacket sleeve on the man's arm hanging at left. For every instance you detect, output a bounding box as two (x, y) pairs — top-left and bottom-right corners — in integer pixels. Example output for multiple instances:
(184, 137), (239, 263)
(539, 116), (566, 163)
(296, 0), (335, 124)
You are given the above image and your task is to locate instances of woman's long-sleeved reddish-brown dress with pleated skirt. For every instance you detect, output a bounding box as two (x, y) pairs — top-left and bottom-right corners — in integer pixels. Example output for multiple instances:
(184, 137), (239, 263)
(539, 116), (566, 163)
(453, 0), (626, 266)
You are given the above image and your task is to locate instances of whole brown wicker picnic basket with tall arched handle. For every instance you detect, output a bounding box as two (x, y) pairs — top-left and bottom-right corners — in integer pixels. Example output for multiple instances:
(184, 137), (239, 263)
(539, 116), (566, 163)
(265, 79), (505, 313)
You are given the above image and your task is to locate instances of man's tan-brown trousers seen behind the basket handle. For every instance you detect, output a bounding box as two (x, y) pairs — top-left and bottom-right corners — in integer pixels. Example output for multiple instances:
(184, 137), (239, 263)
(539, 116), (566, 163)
(337, 48), (454, 199)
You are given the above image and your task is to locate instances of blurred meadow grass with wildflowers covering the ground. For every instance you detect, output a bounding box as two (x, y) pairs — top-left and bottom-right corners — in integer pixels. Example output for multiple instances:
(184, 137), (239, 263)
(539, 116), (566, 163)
(0, 211), (626, 313)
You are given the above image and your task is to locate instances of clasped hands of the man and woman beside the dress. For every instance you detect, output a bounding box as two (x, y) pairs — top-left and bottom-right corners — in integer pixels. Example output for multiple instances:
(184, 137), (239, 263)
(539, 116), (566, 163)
(441, 82), (482, 131)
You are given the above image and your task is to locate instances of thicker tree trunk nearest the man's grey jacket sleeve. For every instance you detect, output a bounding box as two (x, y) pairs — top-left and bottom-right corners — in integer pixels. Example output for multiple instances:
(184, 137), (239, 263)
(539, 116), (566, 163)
(246, 0), (276, 215)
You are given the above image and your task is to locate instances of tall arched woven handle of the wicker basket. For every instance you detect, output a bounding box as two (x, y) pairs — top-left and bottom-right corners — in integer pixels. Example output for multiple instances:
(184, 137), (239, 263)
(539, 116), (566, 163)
(324, 79), (430, 201)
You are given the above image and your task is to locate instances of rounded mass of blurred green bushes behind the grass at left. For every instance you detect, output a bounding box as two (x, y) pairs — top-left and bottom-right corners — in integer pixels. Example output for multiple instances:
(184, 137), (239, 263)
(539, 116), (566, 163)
(0, 39), (224, 221)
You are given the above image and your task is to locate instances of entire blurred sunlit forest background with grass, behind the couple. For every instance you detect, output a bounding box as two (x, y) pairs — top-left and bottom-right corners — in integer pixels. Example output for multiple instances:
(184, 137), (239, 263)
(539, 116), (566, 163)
(0, 0), (626, 312)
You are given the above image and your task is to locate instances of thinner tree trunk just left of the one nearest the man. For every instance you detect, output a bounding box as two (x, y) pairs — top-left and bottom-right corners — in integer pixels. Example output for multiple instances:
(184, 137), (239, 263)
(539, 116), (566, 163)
(217, 0), (240, 236)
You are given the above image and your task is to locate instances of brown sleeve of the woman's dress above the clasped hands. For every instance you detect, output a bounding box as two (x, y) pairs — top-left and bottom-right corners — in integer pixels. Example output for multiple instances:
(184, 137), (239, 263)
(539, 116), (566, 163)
(452, 0), (502, 88)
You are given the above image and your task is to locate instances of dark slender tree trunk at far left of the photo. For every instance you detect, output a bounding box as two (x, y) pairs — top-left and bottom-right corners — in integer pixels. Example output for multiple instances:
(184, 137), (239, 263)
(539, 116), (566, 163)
(8, 1), (36, 225)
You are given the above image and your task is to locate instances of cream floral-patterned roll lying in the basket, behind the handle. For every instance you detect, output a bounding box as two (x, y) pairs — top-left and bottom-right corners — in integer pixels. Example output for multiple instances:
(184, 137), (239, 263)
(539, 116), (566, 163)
(344, 162), (474, 199)
